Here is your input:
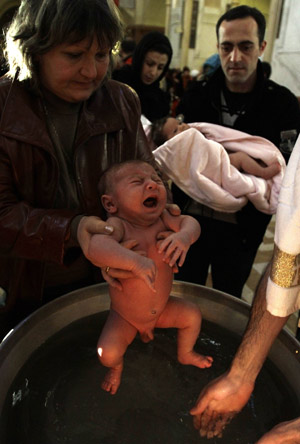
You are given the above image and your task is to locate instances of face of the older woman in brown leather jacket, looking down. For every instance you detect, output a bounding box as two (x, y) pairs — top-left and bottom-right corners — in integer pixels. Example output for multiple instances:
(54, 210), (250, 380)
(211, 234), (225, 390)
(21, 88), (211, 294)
(38, 37), (110, 103)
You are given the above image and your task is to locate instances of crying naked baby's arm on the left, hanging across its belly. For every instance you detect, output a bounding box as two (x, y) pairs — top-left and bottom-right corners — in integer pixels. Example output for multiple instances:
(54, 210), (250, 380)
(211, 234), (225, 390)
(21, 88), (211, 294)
(89, 217), (156, 291)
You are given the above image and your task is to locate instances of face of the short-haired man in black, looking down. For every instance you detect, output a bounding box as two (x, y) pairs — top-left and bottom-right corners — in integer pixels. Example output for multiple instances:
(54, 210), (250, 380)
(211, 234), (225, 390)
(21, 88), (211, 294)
(218, 17), (266, 92)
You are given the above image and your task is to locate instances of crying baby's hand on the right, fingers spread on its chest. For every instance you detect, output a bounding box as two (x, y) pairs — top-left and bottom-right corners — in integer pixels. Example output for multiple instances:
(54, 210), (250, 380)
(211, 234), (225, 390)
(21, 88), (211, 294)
(158, 232), (190, 267)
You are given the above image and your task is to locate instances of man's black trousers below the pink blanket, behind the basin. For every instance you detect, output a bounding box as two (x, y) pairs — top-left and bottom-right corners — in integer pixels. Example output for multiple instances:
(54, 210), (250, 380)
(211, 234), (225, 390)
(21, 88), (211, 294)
(175, 209), (271, 298)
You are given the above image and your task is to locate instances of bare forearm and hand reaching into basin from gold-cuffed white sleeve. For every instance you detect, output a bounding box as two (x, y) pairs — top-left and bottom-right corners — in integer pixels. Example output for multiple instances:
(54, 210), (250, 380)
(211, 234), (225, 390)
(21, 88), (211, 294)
(190, 265), (288, 438)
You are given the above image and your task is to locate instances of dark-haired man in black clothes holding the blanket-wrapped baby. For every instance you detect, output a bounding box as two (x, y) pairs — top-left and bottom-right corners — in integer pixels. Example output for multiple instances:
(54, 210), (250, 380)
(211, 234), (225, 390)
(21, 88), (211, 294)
(173, 6), (300, 297)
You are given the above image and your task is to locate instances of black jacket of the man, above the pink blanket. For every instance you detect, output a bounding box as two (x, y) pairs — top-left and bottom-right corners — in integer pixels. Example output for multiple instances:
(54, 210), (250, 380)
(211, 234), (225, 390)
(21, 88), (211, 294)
(176, 62), (300, 148)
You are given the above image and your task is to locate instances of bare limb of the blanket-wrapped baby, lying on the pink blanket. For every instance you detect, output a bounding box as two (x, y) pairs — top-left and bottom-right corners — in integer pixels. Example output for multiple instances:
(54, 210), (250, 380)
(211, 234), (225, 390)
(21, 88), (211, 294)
(228, 151), (281, 180)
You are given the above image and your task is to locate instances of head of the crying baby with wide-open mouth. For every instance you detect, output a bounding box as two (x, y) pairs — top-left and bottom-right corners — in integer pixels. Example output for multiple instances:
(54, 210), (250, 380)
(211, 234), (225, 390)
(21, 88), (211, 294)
(98, 160), (167, 225)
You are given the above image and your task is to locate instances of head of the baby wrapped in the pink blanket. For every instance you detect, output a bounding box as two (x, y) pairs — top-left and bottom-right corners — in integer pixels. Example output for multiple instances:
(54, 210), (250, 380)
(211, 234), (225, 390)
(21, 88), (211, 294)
(151, 117), (189, 146)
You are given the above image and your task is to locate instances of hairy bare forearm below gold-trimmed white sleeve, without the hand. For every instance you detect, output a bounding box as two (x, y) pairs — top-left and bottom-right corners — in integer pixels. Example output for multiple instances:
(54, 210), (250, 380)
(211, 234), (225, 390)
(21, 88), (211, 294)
(230, 266), (288, 383)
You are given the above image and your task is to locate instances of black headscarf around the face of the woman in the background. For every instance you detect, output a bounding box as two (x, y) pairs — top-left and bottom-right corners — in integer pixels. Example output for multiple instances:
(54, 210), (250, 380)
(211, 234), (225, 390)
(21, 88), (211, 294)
(112, 31), (173, 122)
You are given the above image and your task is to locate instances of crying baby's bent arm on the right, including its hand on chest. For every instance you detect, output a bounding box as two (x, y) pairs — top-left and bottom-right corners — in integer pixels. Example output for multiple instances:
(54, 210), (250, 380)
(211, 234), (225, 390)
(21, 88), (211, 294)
(158, 211), (201, 267)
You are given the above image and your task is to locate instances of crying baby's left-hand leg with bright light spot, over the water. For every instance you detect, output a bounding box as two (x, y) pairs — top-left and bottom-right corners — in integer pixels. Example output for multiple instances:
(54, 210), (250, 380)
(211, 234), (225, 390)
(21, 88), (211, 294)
(97, 310), (137, 395)
